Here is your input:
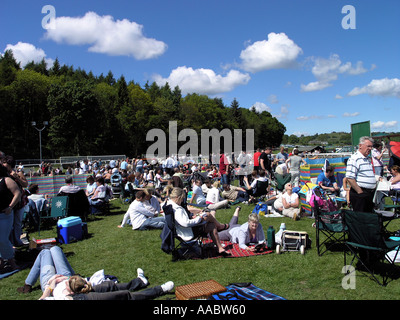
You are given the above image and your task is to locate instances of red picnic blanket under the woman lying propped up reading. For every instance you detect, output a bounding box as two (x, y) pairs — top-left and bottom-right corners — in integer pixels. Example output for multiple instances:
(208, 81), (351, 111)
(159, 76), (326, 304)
(203, 239), (273, 259)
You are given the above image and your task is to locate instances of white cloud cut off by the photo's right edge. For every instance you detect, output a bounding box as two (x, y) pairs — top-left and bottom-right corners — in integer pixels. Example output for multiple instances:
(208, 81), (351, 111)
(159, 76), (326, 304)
(348, 78), (400, 98)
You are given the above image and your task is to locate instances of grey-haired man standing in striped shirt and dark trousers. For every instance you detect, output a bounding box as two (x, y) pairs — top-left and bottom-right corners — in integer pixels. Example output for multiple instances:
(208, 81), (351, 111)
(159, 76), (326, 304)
(346, 136), (376, 212)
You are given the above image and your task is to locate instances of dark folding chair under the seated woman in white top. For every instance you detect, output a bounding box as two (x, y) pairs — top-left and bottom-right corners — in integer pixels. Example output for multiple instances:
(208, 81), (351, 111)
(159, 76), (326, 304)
(160, 204), (203, 261)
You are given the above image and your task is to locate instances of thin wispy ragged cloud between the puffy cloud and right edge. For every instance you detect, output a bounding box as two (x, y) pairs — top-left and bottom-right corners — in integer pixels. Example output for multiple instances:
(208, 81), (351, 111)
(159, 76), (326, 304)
(301, 54), (367, 92)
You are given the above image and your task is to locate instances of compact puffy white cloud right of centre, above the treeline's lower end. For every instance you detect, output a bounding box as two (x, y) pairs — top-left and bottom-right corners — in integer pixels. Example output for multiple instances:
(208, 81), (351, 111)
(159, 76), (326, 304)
(240, 32), (302, 72)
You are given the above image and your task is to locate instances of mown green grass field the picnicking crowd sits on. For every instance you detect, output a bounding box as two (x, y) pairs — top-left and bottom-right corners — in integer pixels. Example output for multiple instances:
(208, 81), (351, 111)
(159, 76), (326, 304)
(0, 199), (400, 300)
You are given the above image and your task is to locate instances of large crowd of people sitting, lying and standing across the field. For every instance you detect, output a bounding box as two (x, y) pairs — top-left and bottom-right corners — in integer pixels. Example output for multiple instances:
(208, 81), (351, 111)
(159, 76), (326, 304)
(0, 137), (400, 299)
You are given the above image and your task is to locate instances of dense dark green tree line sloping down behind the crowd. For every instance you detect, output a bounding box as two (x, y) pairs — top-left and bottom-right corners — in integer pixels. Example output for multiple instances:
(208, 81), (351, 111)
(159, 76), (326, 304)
(0, 50), (286, 159)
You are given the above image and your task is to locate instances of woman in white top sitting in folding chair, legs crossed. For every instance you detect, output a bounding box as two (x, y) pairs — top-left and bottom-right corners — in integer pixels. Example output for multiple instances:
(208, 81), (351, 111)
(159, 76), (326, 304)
(167, 188), (229, 256)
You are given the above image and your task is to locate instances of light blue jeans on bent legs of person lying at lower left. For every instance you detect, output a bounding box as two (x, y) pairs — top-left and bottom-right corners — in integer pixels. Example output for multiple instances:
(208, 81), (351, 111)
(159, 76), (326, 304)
(25, 246), (75, 291)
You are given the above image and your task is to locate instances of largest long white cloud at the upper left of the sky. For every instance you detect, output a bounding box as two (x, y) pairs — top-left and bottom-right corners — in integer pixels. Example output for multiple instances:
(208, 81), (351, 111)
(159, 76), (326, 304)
(45, 12), (167, 60)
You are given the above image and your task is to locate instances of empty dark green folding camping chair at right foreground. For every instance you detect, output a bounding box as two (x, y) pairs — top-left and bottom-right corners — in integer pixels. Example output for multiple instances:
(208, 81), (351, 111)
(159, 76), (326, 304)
(343, 210), (400, 286)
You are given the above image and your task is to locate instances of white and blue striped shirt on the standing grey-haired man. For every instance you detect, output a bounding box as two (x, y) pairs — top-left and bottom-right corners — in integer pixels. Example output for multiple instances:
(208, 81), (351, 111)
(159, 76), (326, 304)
(346, 151), (376, 189)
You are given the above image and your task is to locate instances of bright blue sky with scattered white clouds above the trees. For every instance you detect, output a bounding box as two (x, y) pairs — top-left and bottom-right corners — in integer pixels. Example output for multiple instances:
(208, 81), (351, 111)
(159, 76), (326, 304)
(0, 0), (400, 135)
